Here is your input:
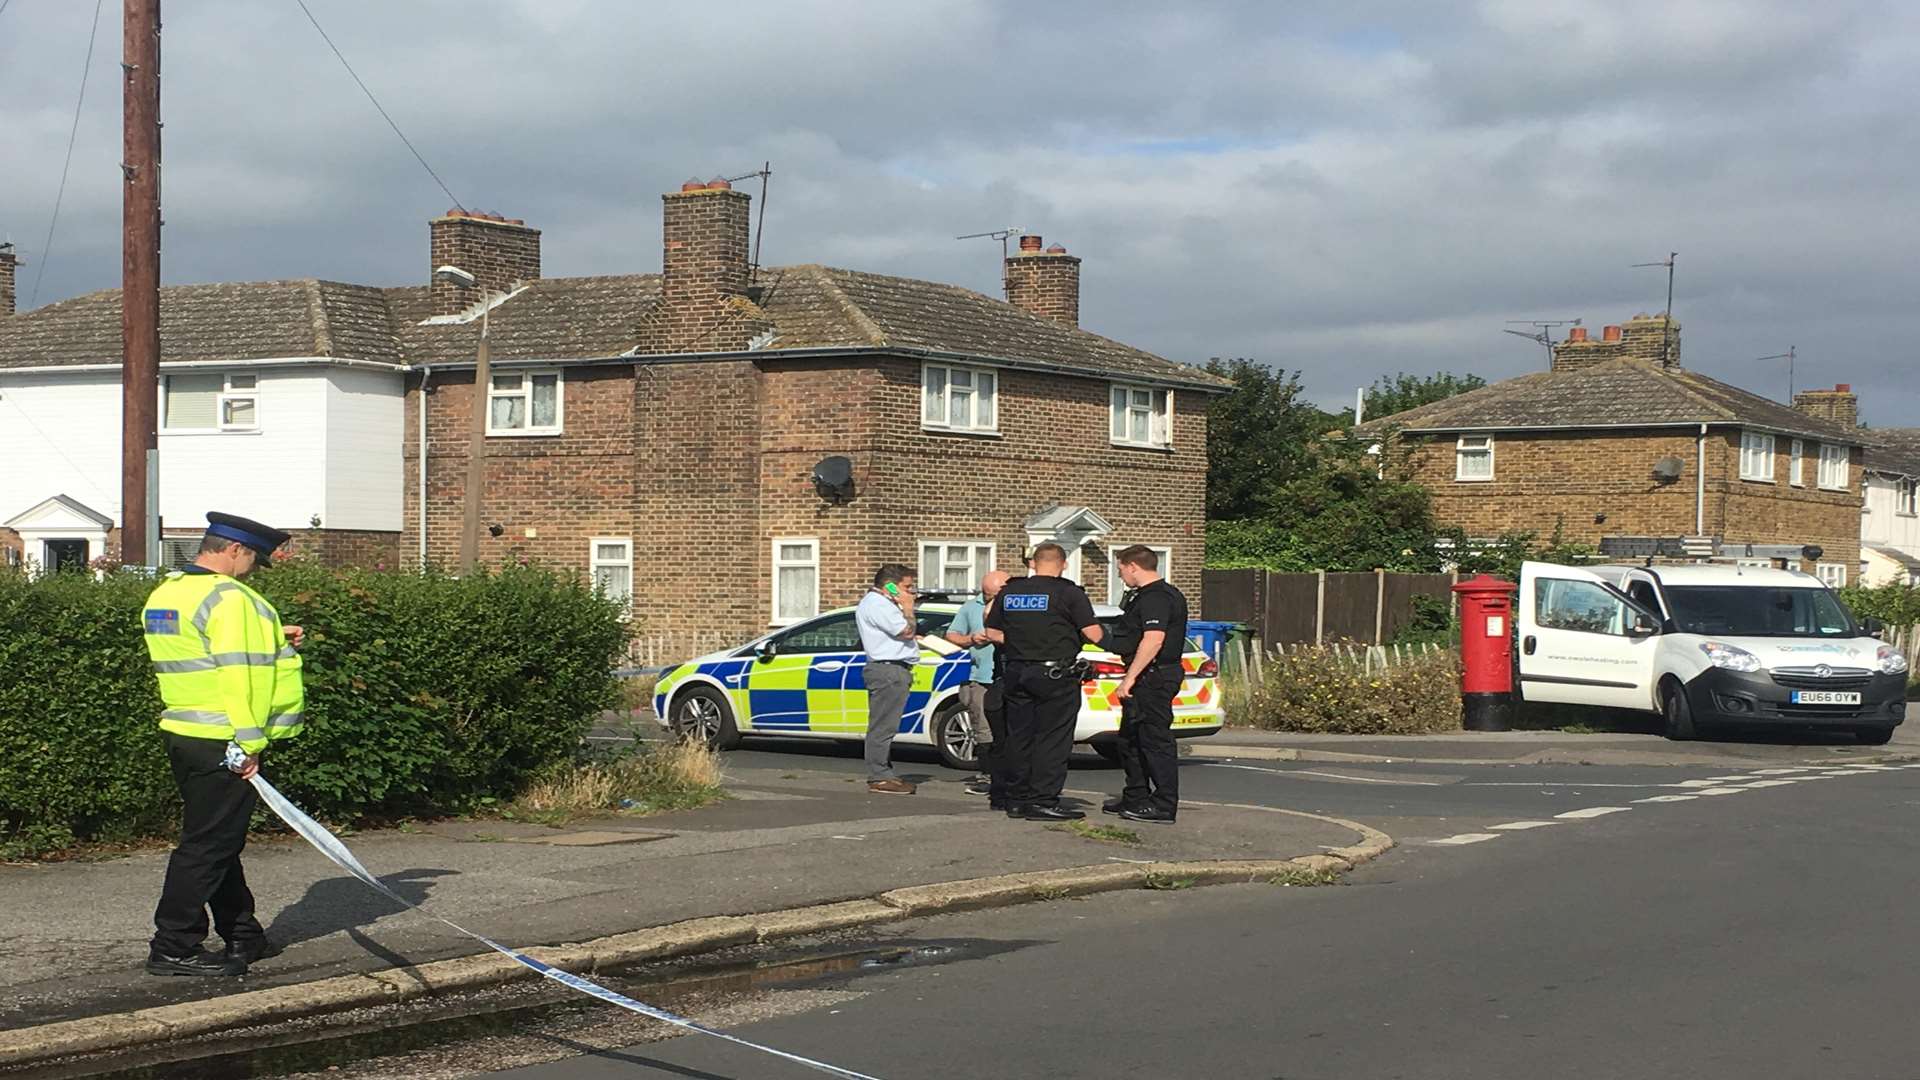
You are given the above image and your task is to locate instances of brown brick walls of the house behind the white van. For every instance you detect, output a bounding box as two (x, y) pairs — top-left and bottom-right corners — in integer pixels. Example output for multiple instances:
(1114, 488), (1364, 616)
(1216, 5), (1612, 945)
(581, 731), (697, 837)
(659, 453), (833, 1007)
(1404, 429), (1860, 575)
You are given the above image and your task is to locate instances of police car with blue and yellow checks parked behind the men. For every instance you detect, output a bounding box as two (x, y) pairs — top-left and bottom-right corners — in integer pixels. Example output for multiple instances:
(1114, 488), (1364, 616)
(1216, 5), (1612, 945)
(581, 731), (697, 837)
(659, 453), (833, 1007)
(653, 594), (1223, 769)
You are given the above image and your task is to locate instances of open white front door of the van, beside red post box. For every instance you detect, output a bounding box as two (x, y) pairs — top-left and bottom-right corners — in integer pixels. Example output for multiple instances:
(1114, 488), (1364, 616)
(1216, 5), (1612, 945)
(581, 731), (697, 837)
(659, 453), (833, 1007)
(1517, 563), (1659, 711)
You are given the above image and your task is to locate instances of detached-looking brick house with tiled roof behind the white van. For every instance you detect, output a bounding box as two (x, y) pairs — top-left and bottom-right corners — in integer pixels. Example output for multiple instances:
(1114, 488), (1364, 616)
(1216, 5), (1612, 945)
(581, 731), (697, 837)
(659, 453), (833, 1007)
(1363, 315), (1866, 582)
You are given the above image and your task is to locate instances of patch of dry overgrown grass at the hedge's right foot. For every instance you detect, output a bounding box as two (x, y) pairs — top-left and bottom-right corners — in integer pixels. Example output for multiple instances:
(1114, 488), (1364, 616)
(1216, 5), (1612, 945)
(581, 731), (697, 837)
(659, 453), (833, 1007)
(501, 742), (726, 824)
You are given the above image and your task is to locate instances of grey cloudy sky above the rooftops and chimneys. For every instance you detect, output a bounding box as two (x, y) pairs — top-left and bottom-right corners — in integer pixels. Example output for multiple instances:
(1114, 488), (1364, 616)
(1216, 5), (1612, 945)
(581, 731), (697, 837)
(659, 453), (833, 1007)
(0, 0), (1920, 417)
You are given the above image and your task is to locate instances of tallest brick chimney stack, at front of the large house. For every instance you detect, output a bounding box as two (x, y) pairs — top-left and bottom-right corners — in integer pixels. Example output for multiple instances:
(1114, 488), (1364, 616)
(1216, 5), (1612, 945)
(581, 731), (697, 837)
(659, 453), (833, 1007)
(645, 179), (753, 352)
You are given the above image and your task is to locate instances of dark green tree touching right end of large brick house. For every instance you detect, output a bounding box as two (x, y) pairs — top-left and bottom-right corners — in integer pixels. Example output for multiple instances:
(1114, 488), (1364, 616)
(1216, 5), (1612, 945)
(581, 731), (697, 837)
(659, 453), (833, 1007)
(1206, 357), (1340, 521)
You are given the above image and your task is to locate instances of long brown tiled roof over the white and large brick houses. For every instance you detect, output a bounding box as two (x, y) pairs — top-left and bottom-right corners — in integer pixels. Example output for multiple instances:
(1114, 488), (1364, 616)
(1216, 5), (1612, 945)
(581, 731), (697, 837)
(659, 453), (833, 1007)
(0, 265), (1231, 388)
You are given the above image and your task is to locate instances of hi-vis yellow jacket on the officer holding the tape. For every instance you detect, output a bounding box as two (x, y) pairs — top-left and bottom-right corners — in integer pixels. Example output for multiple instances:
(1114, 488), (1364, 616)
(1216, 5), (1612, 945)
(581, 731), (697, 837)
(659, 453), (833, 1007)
(144, 573), (307, 753)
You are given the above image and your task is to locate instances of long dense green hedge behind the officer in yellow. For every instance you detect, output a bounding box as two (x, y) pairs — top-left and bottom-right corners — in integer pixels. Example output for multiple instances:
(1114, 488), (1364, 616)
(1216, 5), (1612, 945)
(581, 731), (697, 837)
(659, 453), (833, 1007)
(0, 563), (626, 853)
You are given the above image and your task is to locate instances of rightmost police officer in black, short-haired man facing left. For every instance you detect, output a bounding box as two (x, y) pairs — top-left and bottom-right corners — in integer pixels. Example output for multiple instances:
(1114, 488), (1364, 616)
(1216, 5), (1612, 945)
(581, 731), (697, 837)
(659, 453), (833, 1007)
(1100, 544), (1187, 824)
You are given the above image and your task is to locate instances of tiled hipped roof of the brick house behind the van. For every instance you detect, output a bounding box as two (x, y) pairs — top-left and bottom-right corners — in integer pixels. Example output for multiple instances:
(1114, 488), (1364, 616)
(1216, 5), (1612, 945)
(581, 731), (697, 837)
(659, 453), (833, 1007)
(1361, 359), (1872, 446)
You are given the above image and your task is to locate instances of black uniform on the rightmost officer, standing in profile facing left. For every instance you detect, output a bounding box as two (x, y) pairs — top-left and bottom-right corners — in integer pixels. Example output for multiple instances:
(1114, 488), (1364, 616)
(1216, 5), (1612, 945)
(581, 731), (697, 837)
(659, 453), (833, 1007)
(1119, 578), (1187, 815)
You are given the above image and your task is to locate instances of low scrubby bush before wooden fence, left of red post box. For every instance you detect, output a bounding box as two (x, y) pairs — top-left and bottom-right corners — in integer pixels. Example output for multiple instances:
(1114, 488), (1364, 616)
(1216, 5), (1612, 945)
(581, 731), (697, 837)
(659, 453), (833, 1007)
(1236, 648), (1461, 734)
